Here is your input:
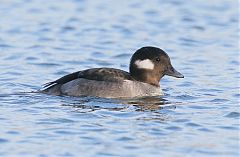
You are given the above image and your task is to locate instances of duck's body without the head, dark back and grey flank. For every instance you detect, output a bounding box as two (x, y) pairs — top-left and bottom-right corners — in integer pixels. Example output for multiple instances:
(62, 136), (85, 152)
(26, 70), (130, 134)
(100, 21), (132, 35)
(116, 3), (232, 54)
(43, 68), (163, 98)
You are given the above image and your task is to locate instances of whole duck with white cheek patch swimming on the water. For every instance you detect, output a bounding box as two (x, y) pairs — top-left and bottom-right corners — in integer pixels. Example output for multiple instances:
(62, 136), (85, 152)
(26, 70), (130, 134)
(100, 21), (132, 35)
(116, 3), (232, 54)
(41, 47), (184, 98)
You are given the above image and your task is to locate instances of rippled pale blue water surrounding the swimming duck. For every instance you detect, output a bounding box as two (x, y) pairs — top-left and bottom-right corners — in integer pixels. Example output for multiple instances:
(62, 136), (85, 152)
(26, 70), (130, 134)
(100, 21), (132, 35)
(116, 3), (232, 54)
(0, 0), (240, 157)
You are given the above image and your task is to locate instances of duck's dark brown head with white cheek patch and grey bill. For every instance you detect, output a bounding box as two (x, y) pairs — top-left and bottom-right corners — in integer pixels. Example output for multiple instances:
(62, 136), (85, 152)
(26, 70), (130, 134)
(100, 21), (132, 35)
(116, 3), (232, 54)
(129, 46), (184, 86)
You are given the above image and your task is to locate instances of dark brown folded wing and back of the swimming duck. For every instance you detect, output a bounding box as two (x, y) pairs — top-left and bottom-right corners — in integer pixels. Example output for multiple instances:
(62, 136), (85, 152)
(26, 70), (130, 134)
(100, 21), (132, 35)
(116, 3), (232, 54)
(43, 68), (134, 88)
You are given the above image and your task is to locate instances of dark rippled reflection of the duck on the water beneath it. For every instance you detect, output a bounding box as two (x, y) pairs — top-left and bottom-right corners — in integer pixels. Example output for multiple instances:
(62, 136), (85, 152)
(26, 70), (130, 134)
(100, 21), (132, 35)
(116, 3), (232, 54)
(62, 97), (176, 112)
